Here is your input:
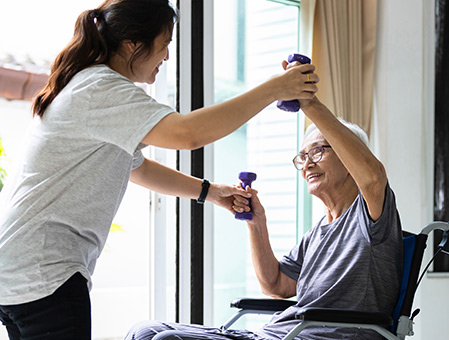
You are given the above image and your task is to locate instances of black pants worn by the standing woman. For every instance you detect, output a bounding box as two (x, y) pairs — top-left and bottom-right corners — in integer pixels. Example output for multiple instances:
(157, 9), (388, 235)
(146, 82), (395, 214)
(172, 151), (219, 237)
(0, 273), (91, 340)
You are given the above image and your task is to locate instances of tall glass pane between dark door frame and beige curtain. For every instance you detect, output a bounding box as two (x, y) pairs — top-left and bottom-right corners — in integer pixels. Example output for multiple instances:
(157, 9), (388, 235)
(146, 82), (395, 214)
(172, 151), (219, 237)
(214, 0), (302, 328)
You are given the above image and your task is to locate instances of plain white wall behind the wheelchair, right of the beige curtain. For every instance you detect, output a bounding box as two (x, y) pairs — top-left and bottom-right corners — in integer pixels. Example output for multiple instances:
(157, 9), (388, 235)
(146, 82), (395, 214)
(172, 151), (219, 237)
(374, 0), (449, 340)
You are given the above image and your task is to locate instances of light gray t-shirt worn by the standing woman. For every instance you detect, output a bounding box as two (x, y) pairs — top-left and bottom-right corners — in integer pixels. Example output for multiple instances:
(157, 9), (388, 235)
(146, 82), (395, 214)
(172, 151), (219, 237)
(0, 65), (174, 305)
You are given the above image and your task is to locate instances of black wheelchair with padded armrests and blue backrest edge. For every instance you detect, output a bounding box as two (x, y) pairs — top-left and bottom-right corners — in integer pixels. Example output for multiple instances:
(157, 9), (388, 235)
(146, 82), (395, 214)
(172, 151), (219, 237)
(222, 222), (449, 340)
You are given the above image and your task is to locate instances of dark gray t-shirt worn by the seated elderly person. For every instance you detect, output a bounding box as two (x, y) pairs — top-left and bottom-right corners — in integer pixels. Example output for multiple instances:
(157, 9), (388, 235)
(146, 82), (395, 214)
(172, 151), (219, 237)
(256, 186), (402, 340)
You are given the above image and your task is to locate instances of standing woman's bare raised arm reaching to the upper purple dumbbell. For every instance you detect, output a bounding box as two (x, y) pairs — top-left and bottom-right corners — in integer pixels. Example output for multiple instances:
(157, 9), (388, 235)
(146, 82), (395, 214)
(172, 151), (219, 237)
(143, 65), (317, 149)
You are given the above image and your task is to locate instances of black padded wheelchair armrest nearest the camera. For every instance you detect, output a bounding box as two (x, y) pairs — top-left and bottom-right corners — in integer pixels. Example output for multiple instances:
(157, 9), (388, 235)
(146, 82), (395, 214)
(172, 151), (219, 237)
(295, 307), (393, 326)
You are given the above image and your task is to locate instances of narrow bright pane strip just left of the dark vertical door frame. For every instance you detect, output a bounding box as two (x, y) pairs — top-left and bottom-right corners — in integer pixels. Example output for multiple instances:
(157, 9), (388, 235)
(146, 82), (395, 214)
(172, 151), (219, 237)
(146, 0), (177, 322)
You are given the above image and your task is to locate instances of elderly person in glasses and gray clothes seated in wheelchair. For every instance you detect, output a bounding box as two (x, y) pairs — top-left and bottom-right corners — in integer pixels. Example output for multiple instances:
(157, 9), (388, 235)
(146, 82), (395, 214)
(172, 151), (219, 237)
(127, 94), (402, 340)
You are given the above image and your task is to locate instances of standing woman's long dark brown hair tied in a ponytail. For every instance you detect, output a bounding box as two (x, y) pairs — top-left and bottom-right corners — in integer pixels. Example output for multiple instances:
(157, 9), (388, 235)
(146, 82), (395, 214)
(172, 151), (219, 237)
(32, 0), (177, 117)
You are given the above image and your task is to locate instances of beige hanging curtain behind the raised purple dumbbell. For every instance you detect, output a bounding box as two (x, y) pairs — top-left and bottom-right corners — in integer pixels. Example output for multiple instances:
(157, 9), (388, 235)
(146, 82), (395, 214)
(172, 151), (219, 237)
(301, 0), (377, 134)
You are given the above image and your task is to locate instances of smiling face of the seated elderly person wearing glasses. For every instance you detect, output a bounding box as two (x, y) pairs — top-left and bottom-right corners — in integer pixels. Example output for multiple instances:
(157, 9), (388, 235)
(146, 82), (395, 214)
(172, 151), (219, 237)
(301, 130), (350, 198)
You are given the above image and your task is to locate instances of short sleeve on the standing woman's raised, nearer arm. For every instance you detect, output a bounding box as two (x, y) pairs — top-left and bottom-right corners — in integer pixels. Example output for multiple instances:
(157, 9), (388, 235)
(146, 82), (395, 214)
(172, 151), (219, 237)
(85, 74), (174, 155)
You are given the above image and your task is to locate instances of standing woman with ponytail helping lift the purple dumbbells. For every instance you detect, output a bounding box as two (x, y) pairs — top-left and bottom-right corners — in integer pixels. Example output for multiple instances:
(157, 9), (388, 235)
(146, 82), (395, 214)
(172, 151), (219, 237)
(0, 0), (318, 340)
